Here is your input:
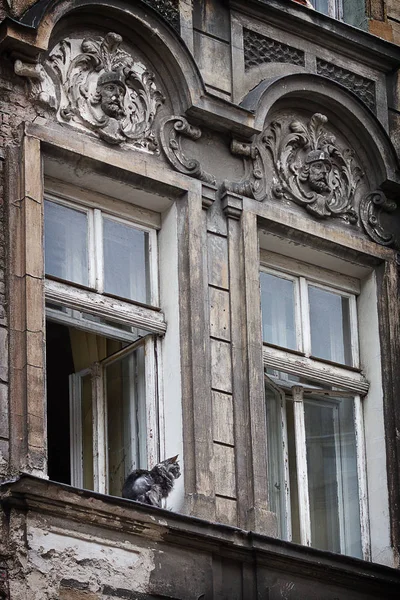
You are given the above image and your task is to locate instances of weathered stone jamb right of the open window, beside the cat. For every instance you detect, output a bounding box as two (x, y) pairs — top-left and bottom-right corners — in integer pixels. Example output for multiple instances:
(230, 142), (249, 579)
(178, 184), (215, 520)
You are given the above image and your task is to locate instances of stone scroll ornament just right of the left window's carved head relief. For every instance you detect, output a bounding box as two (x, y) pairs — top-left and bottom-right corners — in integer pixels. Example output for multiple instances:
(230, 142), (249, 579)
(161, 116), (216, 185)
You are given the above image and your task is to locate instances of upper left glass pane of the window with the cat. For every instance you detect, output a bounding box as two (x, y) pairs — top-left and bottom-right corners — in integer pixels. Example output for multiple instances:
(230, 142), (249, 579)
(44, 200), (89, 286)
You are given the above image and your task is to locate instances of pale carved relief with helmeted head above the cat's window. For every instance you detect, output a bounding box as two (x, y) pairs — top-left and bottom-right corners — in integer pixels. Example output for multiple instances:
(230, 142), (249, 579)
(15, 33), (165, 152)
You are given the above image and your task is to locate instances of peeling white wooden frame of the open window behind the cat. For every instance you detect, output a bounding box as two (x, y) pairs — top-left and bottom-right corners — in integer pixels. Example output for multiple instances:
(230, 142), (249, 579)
(45, 192), (167, 494)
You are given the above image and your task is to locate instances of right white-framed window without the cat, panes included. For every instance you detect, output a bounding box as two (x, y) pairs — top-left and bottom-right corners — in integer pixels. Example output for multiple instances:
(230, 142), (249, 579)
(260, 252), (369, 559)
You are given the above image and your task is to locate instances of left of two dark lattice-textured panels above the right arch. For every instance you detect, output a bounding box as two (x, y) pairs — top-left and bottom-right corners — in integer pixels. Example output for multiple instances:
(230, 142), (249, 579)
(243, 29), (305, 71)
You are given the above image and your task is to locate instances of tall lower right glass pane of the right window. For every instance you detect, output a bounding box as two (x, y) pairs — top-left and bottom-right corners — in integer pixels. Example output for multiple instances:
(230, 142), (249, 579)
(304, 398), (362, 558)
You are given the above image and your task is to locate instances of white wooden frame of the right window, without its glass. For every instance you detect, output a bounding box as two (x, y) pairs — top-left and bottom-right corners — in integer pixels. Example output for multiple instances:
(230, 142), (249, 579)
(260, 250), (371, 560)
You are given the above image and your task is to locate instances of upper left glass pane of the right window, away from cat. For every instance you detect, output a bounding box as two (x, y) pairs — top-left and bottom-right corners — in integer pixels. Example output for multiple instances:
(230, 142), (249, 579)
(260, 272), (297, 350)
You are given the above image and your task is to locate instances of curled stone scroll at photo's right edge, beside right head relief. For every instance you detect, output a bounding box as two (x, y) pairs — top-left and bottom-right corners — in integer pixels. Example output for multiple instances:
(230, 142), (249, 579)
(360, 190), (398, 247)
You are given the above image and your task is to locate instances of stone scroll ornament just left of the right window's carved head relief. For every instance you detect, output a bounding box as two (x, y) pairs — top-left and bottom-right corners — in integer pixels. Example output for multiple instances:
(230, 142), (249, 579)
(222, 140), (266, 202)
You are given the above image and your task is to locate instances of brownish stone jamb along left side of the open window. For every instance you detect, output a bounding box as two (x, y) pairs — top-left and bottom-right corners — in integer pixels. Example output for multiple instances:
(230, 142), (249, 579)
(7, 135), (47, 477)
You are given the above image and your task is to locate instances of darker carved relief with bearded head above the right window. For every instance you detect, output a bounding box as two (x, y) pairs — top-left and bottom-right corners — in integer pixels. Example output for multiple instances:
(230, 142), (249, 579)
(263, 113), (362, 224)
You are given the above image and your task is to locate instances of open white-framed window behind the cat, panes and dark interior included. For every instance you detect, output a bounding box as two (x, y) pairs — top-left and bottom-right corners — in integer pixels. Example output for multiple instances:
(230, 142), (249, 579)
(44, 194), (162, 496)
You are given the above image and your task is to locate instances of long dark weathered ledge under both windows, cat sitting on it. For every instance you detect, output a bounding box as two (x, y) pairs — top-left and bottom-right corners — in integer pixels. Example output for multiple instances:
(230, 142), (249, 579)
(0, 474), (400, 584)
